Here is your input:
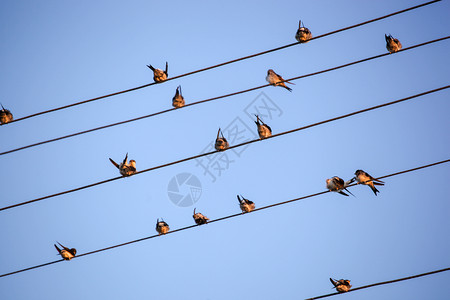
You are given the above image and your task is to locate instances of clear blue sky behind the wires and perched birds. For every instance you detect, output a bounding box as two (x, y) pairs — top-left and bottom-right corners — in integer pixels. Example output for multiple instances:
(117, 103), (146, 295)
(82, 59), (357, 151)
(0, 0), (450, 300)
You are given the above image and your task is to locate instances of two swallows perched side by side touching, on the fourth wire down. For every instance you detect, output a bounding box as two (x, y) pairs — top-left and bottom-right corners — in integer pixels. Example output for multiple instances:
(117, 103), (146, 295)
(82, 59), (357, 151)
(326, 170), (384, 196)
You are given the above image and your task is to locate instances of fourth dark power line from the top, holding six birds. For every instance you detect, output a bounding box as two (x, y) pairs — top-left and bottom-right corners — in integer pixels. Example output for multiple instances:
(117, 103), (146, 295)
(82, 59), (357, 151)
(0, 159), (450, 278)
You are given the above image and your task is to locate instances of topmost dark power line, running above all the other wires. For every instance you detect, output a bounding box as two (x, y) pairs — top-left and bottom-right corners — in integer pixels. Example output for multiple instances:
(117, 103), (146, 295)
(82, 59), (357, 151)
(5, 0), (441, 125)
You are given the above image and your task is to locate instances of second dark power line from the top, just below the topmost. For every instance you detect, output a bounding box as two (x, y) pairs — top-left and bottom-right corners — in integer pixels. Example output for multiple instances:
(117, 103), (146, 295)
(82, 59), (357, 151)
(0, 36), (450, 156)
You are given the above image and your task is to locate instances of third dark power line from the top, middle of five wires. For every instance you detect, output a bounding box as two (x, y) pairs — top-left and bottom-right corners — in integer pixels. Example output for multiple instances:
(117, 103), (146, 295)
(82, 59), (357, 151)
(0, 85), (450, 211)
